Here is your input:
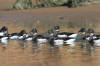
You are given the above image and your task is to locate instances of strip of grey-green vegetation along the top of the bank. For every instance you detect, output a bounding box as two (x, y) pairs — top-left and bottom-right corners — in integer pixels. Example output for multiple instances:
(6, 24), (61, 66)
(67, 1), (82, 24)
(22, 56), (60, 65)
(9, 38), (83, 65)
(13, 0), (100, 10)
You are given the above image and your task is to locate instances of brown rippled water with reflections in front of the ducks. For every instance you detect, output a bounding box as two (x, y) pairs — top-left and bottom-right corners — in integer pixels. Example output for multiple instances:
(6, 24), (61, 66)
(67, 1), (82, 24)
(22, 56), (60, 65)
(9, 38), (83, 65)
(0, 41), (100, 66)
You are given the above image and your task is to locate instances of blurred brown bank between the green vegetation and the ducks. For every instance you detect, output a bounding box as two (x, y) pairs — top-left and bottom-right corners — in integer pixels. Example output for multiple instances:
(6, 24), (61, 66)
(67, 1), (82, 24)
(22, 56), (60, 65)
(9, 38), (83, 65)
(0, 5), (100, 32)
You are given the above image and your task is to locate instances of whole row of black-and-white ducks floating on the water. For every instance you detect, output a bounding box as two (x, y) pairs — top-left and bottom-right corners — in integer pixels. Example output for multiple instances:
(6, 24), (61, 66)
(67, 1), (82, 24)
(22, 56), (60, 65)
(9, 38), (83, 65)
(0, 26), (100, 49)
